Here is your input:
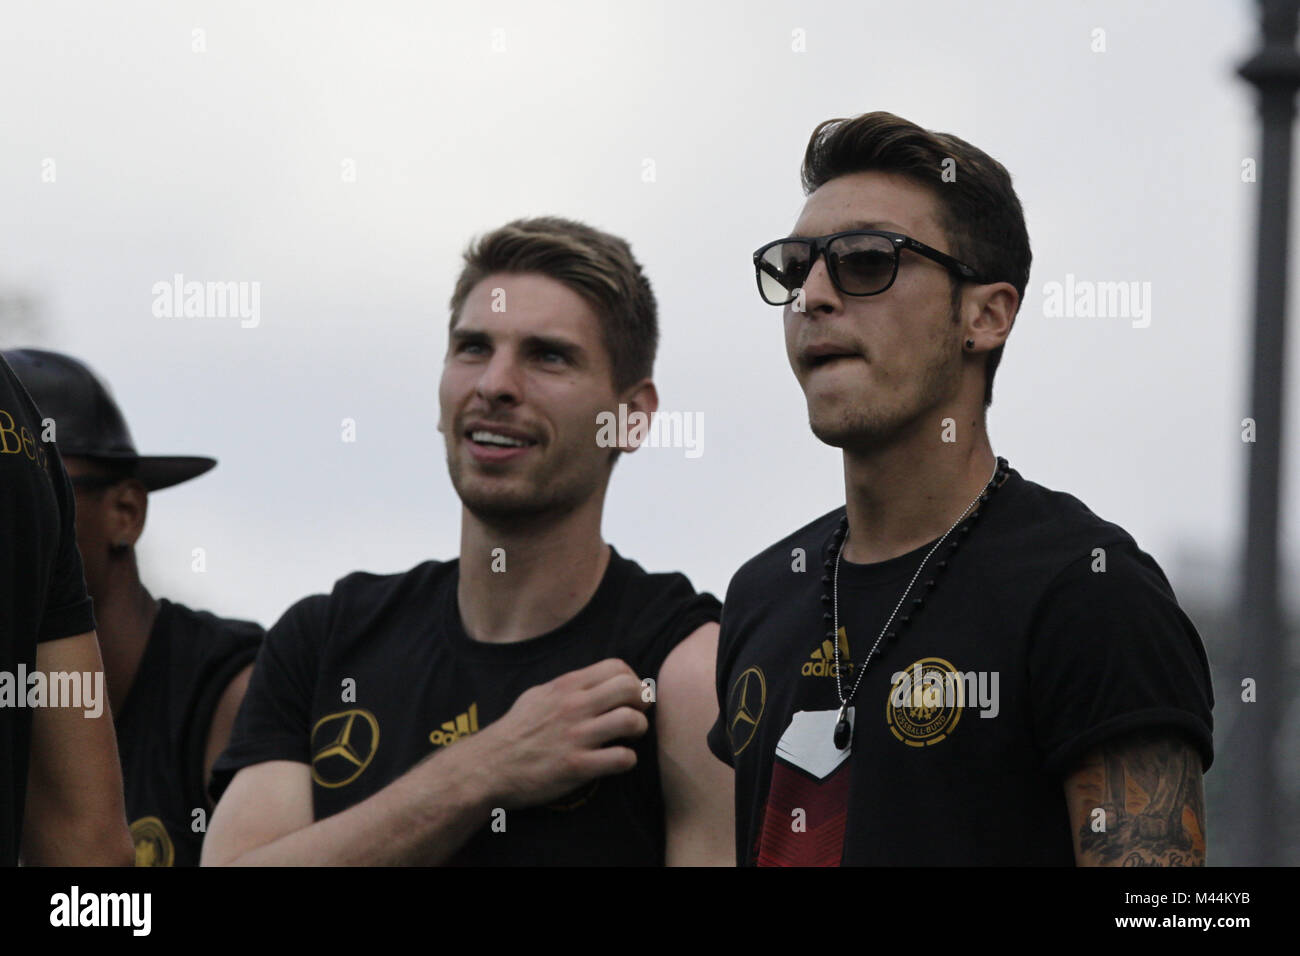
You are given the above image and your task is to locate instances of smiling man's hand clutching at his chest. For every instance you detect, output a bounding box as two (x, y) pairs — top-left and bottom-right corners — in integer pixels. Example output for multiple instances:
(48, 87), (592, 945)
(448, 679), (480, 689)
(455, 658), (650, 809)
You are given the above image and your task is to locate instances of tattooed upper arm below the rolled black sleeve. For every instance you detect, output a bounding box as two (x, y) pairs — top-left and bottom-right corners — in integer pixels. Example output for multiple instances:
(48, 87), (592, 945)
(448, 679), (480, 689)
(1066, 732), (1205, 866)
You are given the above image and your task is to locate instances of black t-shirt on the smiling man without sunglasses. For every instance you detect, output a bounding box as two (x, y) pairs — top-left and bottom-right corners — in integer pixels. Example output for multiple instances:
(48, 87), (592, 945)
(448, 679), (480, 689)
(212, 548), (720, 865)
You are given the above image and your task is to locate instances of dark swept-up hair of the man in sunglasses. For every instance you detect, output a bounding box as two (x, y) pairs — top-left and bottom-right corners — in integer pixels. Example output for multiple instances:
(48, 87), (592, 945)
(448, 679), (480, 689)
(802, 112), (1032, 407)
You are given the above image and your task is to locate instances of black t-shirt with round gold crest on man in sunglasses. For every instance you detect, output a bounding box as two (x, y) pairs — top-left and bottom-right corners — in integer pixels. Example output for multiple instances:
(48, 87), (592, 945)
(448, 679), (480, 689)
(709, 470), (1213, 866)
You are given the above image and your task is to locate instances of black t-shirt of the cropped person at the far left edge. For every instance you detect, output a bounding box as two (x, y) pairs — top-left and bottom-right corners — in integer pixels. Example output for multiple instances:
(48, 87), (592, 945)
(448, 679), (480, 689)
(0, 358), (95, 866)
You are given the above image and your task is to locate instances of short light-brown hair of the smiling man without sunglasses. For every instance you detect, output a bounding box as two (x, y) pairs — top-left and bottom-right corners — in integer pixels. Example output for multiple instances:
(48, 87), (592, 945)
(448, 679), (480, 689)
(451, 216), (659, 390)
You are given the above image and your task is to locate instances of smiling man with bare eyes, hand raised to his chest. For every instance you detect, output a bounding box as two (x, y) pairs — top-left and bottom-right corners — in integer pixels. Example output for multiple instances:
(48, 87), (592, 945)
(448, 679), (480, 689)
(204, 217), (735, 865)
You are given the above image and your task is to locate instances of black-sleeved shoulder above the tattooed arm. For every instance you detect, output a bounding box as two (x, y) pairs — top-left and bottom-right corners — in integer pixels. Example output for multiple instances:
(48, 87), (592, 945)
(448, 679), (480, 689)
(998, 483), (1214, 770)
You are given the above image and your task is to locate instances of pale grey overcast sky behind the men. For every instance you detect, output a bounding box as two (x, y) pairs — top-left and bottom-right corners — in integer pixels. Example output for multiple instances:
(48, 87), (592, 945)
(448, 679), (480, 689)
(0, 0), (1300, 624)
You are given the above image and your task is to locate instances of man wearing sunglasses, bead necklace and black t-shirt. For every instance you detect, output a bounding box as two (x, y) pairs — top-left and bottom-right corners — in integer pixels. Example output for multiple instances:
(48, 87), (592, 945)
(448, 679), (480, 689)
(710, 113), (1213, 866)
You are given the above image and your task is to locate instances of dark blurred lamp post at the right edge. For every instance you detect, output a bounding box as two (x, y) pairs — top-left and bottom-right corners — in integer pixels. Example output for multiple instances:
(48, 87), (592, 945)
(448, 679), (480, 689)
(1227, 0), (1300, 866)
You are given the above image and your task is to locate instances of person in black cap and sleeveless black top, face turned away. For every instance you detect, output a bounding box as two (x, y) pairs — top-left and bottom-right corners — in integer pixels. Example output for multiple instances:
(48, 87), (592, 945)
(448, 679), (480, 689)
(5, 349), (263, 866)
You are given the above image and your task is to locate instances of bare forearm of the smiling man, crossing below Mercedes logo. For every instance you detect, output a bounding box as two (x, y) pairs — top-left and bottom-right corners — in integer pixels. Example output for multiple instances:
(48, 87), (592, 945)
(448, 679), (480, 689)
(220, 744), (493, 866)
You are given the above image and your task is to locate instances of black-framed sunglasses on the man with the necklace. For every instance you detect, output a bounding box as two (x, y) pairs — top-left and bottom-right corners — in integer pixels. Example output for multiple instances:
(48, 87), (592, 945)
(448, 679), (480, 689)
(754, 229), (985, 306)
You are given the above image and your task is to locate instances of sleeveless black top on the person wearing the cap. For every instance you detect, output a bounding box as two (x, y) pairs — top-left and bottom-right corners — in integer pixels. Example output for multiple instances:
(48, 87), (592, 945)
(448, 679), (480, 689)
(114, 598), (264, 866)
